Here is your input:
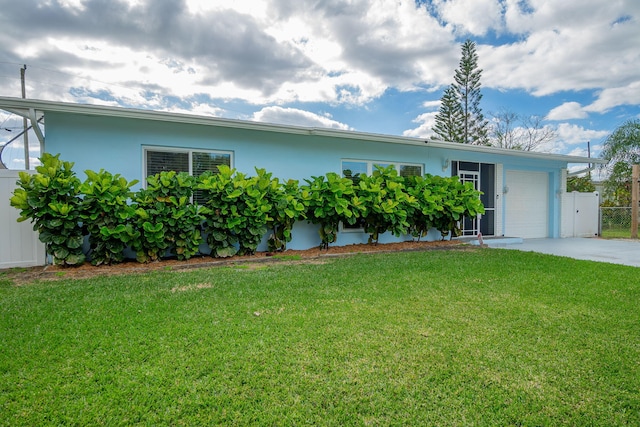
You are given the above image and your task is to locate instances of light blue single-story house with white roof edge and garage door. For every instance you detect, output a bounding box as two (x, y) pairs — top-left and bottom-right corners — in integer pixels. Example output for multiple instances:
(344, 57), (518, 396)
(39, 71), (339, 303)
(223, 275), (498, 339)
(0, 97), (602, 249)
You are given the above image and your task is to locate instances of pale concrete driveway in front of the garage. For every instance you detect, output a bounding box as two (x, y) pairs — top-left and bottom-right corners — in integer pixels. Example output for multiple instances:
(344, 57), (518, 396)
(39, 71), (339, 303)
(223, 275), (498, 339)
(504, 237), (640, 267)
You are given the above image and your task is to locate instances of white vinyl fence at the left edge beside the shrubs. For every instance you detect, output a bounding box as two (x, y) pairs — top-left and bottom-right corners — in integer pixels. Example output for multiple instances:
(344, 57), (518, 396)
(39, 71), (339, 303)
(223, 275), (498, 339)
(0, 169), (46, 269)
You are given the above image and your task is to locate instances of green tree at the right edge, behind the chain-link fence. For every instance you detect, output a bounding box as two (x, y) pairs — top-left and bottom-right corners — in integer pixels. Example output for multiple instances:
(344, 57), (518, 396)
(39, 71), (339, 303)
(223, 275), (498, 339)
(600, 119), (640, 206)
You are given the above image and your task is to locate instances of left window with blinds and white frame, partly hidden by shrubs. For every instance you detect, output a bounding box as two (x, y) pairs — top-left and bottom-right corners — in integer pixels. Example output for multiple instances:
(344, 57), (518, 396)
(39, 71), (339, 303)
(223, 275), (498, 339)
(143, 147), (233, 202)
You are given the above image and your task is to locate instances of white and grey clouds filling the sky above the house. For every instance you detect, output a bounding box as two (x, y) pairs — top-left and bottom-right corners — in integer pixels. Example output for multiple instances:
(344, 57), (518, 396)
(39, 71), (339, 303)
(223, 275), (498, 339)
(0, 0), (640, 111)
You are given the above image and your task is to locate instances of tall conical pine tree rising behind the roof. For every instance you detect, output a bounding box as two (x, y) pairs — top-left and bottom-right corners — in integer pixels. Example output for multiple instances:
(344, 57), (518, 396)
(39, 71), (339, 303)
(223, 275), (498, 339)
(434, 40), (489, 145)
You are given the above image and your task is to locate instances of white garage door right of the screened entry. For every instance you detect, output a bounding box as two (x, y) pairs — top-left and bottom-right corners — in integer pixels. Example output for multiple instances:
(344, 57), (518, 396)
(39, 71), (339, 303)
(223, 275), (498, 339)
(505, 171), (549, 239)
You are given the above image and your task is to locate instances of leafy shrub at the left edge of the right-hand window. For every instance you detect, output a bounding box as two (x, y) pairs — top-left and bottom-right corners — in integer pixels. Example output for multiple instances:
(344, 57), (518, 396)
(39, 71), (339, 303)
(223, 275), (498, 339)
(300, 172), (360, 249)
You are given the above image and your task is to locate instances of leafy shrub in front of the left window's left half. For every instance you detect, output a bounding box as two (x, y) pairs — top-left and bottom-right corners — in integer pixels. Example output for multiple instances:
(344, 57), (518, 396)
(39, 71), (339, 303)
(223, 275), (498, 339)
(133, 171), (204, 262)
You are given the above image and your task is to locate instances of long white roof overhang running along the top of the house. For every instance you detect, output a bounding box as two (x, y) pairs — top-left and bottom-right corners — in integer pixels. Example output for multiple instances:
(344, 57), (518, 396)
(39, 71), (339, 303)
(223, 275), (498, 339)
(0, 97), (607, 164)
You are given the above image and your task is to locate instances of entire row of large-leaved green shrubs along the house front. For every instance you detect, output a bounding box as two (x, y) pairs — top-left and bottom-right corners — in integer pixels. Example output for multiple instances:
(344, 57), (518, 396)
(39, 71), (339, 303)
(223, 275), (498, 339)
(11, 153), (484, 265)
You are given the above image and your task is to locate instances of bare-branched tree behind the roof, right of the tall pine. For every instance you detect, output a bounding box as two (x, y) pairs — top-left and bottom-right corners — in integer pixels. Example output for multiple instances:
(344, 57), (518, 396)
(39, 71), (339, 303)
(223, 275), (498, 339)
(489, 109), (556, 151)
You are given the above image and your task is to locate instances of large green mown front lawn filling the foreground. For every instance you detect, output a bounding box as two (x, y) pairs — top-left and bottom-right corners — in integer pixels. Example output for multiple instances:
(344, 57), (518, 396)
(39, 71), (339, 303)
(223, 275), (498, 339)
(0, 249), (640, 426)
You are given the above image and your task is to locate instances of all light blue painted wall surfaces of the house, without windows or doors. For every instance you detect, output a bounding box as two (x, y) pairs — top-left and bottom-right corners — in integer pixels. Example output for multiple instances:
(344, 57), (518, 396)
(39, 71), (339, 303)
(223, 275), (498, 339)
(45, 112), (566, 249)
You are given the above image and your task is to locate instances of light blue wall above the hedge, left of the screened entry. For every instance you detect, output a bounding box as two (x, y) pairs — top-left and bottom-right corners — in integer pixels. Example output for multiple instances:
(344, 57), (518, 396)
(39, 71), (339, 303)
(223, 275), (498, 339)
(45, 113), (442, 185)
